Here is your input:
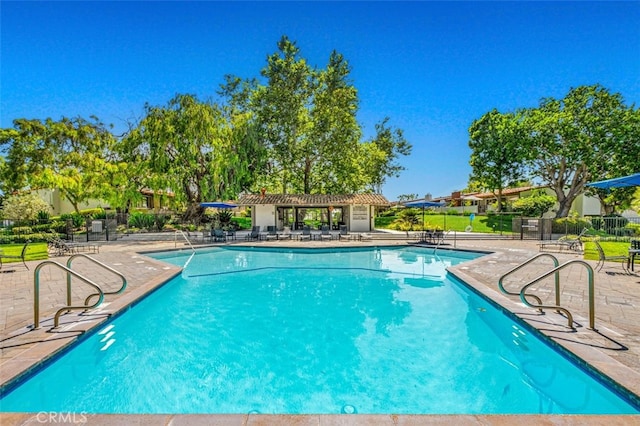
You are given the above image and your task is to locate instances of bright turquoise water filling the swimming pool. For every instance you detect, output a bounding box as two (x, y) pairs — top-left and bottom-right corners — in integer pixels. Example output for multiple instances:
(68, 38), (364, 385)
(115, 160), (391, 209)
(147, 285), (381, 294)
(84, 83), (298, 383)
(0, 247), (638, 414)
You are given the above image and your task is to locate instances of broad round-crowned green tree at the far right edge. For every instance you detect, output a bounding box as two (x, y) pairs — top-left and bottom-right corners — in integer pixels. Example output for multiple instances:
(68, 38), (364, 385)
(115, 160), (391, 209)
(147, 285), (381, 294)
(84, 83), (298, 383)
(525, 85), (640, 217)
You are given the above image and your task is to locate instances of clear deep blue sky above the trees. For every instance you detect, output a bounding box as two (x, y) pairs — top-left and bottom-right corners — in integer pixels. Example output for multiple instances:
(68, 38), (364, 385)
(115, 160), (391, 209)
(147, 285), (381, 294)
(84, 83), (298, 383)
(0, 1), (640, 200)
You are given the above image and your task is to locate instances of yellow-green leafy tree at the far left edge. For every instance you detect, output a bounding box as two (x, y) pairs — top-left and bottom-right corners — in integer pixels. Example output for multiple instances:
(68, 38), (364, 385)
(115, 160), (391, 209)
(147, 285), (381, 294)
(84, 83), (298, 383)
(0, 117), (114, 212)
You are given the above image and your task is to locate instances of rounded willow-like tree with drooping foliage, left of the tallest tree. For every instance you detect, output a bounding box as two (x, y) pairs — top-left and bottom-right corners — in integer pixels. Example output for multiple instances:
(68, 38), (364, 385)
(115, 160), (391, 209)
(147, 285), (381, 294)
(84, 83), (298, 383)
(121, 95), (262, 217)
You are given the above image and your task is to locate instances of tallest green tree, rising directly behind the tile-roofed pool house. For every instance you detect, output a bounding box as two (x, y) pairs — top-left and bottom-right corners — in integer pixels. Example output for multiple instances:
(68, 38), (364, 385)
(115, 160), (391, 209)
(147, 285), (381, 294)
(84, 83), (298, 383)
(219, 36), (411, 193)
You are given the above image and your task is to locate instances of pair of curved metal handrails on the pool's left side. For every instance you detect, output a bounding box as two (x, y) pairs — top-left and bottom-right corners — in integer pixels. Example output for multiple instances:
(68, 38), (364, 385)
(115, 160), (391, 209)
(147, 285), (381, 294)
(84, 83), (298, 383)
(33, 253), (127, 329)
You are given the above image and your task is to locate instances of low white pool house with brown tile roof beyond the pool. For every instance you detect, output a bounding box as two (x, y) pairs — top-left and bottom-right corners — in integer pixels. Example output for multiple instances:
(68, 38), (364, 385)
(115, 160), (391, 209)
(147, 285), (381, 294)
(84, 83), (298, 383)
(237, 194), (390, 232)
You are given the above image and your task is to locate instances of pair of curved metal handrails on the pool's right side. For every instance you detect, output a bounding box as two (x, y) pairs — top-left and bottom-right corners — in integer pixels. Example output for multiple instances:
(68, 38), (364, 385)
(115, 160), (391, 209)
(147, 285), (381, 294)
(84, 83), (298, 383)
(498, 253), (596, 330)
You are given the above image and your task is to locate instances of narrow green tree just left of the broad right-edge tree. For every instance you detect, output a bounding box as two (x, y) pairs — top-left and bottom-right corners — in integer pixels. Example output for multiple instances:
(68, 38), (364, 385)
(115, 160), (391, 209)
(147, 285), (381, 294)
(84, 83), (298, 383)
(469, 109), (527, 211)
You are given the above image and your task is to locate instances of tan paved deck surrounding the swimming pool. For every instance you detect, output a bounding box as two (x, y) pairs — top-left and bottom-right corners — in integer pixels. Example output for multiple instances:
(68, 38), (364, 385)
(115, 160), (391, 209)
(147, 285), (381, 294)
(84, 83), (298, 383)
(0, 238), (640, 426)
